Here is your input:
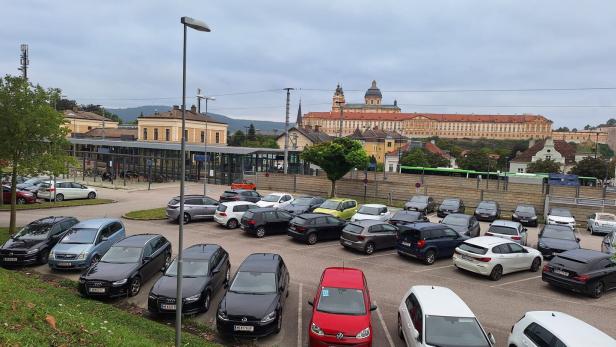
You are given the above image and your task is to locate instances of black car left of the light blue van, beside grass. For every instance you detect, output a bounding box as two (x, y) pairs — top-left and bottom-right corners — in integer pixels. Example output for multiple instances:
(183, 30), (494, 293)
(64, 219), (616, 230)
(0, 217), (79, 266)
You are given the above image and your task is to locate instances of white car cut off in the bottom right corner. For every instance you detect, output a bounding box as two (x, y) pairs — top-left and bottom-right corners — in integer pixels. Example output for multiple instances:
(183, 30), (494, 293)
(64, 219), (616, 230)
(507, 311), (616, 347)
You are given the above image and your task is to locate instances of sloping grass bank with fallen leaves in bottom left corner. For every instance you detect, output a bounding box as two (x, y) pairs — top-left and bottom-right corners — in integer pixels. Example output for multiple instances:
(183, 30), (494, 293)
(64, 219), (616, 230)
(0, 268), (217, 346)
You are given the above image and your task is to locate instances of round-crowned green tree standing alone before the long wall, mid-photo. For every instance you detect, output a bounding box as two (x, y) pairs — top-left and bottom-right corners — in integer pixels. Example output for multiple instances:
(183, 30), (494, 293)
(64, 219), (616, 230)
(301, 137), (369, 197)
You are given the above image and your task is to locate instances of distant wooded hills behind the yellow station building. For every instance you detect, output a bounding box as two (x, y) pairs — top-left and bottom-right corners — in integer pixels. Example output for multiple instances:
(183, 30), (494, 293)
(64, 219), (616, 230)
(105, 105), (286, 134)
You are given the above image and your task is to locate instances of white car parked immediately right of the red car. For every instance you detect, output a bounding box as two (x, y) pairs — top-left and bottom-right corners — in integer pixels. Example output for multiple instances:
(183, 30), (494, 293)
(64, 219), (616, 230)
(398, 286), (496, 347)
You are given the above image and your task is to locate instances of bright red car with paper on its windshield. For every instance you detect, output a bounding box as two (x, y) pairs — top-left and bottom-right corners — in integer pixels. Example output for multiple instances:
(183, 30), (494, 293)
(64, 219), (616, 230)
(308, 267), (376, 347)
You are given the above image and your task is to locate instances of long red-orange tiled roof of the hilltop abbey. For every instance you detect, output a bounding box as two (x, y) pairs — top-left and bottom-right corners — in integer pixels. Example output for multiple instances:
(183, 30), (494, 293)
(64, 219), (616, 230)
(304, 112), (552, 123)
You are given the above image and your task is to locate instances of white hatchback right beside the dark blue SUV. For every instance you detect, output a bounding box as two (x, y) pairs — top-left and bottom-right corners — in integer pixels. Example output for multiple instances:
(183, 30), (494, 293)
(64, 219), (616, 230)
(453, 236), (542, 281)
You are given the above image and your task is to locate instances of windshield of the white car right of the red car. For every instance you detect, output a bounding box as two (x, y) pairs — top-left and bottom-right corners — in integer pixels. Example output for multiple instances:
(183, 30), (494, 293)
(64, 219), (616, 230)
(425, 315), (490, 347)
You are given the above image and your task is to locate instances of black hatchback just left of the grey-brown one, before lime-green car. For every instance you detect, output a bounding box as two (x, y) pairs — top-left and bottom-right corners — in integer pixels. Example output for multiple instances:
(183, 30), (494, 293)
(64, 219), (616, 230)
(287, 213), (346, 245)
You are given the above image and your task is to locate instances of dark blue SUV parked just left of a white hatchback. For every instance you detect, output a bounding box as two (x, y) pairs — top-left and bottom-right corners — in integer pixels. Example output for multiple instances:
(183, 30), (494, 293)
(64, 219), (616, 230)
(396, 223), (468, 265)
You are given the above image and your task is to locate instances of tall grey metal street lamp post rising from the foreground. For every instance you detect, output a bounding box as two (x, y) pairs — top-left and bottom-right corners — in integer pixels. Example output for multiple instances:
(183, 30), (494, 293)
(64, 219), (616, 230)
(175, 17), (210, 347)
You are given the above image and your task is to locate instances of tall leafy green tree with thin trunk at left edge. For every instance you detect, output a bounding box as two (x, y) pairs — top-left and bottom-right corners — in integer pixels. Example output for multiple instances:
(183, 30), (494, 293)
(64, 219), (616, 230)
(0, 75), (73, 233)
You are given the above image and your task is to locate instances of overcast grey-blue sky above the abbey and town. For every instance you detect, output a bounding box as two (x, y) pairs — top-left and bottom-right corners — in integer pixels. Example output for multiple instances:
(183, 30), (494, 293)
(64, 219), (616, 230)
(0, 0), (616, 128)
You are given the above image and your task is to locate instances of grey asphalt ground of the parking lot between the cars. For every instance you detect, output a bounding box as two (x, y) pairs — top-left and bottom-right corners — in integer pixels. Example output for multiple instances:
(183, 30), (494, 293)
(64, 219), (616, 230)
(0, 184), (616, 346)
